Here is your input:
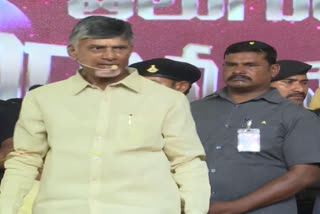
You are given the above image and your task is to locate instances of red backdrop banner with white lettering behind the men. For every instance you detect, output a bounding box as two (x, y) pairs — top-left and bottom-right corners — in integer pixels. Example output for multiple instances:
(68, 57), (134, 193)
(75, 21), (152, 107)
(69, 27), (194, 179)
(0, 0), (320, 103)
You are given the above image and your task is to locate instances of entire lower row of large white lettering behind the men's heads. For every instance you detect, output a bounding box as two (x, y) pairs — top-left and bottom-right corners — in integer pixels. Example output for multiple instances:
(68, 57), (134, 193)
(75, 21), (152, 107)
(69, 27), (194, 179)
(0, 33), (320, 100)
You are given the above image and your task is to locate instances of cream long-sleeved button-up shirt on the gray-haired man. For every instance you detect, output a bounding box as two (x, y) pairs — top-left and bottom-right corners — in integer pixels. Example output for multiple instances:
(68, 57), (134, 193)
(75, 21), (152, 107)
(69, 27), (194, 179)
(0, 71), (210, 214)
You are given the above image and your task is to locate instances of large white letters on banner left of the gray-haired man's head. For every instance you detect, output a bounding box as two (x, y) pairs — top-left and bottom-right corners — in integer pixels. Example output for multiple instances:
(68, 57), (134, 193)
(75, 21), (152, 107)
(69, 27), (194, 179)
(0, 33), (68, 99)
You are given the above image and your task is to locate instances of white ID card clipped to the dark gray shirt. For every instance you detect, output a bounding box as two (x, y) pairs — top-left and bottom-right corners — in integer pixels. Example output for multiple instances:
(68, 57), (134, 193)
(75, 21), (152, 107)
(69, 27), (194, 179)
(237, 128), (260, 152)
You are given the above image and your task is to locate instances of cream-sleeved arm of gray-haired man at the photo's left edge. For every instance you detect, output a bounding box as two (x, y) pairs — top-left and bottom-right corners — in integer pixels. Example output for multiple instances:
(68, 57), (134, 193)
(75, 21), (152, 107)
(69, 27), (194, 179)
(0, 93), (48, 214)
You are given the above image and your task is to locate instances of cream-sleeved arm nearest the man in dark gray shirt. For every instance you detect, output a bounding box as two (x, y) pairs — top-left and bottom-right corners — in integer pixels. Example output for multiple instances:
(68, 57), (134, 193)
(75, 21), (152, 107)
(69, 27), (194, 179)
(163, 94), (210, 214)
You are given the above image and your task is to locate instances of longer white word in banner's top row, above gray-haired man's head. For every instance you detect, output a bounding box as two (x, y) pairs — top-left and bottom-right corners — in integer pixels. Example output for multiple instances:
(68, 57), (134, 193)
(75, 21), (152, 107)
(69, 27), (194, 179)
(68, 0), (244, 21)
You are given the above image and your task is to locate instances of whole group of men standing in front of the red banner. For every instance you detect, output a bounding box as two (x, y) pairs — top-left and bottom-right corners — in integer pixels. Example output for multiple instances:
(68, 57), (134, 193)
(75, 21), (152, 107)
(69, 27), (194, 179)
(0, 16), (320, 214)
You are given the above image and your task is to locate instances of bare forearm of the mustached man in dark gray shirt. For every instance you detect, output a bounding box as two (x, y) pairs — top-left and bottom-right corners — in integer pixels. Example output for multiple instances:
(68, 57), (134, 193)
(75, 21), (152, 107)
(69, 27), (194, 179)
(209, 164), (320, 214)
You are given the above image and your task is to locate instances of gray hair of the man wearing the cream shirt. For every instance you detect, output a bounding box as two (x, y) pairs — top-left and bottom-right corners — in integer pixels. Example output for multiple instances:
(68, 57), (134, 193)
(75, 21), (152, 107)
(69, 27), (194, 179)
(69, 16), (133, 45)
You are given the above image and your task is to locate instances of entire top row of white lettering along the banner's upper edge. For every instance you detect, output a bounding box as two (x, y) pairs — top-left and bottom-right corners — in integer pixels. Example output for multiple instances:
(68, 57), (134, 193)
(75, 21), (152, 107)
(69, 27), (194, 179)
(68, 0), (320, 21)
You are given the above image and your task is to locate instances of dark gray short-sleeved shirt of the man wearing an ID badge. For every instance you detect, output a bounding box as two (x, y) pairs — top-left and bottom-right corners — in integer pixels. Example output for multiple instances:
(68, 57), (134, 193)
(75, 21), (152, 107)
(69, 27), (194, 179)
(191, 88), (320, 214)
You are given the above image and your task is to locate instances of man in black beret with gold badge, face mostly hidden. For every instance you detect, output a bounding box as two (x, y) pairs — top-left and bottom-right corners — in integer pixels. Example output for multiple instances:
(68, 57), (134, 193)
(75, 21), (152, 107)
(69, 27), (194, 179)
(129, 58), (201, 94)
